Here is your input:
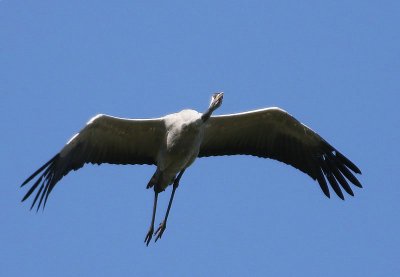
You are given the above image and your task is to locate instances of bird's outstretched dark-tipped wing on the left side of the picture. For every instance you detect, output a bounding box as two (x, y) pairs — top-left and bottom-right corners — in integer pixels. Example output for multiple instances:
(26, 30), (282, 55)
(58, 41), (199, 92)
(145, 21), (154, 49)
(21, 115), (165, 209)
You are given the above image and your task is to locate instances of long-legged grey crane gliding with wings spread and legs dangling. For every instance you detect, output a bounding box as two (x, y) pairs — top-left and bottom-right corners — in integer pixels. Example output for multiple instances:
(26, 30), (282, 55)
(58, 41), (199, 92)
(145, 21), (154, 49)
(21, 92), (362, 245)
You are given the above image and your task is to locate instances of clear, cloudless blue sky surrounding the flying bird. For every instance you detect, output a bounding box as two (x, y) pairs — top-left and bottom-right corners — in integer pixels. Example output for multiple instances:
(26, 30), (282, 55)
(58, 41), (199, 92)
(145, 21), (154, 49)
(0, 0), (400, 276)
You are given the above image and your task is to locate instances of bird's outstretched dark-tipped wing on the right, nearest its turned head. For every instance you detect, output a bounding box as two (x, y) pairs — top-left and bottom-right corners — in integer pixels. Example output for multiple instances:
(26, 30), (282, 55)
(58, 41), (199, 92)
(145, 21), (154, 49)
(199, 108), (362, 199)
